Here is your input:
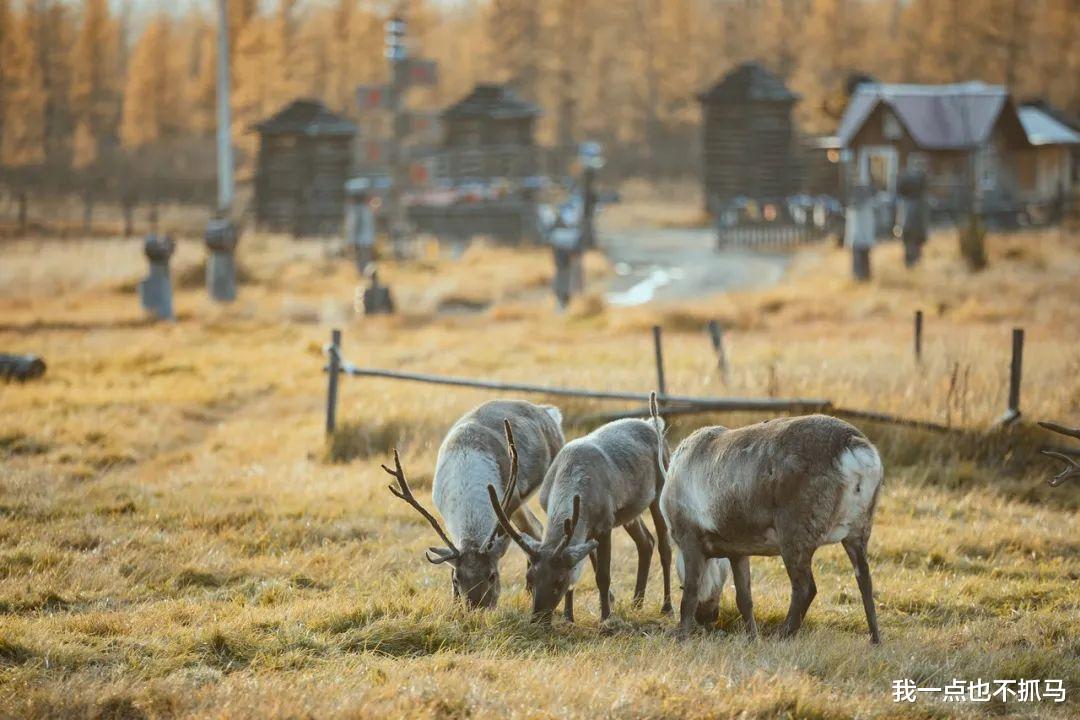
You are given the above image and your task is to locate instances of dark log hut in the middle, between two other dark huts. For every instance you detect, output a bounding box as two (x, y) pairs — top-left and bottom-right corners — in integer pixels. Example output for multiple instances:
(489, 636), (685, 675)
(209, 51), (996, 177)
(435, 83), (540, 182)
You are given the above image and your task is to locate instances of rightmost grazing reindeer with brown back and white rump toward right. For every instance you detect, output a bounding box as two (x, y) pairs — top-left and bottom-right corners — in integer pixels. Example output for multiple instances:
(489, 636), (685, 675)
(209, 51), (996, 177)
(650, 393), (882, 642)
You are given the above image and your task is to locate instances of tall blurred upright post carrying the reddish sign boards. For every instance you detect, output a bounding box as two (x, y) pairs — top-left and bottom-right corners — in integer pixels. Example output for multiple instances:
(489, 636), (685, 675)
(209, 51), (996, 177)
(386, 10), (409, 257)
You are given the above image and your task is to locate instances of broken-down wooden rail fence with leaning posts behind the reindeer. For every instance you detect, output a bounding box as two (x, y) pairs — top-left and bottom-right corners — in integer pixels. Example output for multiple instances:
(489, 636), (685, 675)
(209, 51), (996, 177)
(323, 311), (1024, 435)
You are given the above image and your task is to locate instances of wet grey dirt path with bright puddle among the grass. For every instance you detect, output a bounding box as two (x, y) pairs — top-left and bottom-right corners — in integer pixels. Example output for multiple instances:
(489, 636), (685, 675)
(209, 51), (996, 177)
(600, 228), (791, 305)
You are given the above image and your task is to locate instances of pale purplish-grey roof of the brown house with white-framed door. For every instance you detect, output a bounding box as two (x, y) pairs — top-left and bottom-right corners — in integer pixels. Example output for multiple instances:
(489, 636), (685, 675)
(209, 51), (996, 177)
(837, 82), (1013, 150)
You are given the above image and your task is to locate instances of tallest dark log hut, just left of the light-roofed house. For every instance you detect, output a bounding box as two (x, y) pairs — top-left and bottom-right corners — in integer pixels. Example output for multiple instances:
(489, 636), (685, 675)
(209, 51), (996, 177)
(698, 63), (800, 210)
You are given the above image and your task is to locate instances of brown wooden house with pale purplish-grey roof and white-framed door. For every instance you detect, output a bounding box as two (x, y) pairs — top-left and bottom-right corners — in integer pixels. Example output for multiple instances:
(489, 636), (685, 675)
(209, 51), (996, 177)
(837, 82), (1031, 214)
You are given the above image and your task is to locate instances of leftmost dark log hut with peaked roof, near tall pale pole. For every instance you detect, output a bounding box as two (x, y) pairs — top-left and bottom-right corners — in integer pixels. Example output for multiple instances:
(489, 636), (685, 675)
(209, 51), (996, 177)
(254, 99), (356, 236)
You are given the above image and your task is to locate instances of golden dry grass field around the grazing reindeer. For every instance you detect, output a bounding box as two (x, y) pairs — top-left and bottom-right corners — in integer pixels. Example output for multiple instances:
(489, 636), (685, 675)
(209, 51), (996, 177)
(0, 222), (1080, 718)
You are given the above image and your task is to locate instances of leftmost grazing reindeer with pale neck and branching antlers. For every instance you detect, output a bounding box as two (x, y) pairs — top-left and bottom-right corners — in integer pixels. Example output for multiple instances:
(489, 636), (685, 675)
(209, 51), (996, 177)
(382, 400), (564, 608)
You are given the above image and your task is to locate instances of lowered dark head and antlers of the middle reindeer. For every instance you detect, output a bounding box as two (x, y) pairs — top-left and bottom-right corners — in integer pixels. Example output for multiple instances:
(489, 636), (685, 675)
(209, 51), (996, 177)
(487, 492), (597, 623)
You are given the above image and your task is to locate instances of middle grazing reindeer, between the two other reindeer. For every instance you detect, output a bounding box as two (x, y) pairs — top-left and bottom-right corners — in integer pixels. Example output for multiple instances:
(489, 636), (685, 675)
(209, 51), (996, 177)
(487, 420), (672, 623)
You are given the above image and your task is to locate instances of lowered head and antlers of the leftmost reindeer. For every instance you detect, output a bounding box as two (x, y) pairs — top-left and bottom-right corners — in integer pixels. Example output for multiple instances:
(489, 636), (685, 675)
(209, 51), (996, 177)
(382, 421), (517, 609)
